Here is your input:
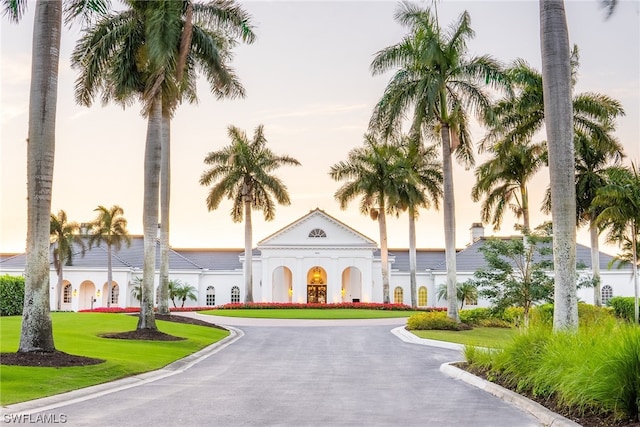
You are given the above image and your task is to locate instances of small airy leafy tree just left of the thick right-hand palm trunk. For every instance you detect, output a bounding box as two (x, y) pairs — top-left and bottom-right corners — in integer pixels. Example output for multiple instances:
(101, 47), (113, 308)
(471, 232), (554, 327)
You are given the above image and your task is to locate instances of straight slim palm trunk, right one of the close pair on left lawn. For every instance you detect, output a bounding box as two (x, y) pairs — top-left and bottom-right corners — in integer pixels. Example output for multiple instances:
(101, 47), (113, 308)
(158, 112), (171, 314)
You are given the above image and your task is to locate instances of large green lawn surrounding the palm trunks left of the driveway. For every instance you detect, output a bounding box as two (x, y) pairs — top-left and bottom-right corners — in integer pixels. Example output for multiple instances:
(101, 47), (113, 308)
(0, 313), (229, 405)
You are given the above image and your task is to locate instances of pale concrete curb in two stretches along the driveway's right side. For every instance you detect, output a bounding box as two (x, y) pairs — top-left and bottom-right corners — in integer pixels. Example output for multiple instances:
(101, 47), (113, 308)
(391, 327), (580, 427)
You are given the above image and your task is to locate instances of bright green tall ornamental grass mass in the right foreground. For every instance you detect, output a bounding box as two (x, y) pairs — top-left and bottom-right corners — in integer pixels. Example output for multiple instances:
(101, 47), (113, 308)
(465, 324), (640, 421)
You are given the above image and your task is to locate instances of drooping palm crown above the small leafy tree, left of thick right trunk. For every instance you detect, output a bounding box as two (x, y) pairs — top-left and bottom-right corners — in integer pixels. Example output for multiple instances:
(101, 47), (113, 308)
(471, 143), (546, 234)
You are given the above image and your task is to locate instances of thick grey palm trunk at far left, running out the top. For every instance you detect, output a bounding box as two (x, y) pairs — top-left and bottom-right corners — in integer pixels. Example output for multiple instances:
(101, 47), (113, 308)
(18, 0), (62, 353)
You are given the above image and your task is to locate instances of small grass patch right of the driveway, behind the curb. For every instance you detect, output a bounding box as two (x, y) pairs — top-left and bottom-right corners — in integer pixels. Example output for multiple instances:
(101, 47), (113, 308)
(411, 328), (519, 348)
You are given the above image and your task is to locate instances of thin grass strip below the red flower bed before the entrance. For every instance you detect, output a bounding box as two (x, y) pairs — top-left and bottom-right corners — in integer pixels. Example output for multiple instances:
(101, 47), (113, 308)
(200, 308), (417, 319)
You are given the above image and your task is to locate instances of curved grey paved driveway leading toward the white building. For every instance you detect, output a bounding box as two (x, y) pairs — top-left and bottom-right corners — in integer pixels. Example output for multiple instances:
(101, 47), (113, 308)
(8, 315), (539, 427)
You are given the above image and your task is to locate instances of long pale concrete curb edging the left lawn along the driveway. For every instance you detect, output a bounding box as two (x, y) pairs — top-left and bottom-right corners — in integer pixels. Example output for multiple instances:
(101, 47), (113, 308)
(1, 326), (244, 415)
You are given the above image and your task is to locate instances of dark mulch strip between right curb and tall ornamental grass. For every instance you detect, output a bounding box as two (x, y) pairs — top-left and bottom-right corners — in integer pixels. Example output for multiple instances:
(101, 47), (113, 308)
(455, 363), (640, 427)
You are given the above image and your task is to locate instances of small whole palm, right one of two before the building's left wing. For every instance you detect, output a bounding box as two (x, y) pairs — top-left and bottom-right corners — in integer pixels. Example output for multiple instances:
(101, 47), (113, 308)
(89, 205), (131, 307)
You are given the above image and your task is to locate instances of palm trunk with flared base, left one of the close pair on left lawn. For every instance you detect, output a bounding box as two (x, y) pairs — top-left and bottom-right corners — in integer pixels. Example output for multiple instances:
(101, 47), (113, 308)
(138, 95), (162, 329)
